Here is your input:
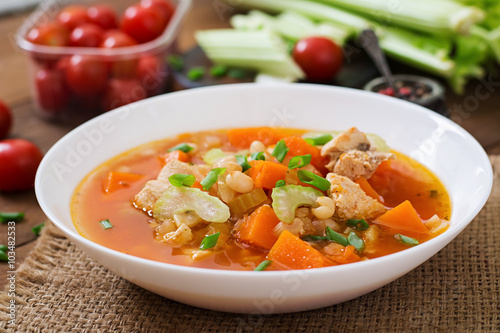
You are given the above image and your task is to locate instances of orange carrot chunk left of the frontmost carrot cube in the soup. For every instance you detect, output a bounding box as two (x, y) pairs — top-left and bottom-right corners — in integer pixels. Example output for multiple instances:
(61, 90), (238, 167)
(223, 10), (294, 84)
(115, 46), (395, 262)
(236, 205), (280, 250)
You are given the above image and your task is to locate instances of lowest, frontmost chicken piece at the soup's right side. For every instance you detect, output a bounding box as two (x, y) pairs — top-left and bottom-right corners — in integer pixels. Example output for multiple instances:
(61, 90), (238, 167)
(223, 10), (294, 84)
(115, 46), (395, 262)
(326, 173), (387, 220)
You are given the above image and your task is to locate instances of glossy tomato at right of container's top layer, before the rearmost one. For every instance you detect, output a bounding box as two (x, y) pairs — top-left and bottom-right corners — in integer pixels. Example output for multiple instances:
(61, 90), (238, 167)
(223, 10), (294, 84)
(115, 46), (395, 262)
(121, 5), (167, 43)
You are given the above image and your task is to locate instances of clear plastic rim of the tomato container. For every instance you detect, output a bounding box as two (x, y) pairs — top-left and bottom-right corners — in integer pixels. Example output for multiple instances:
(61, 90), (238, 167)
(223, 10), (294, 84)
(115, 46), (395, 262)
(14, 0), (192, 58)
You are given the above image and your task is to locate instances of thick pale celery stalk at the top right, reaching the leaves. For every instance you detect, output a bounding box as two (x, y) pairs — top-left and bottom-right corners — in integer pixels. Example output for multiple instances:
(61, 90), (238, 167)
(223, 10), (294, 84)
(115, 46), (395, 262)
(312, 0), (485, 35)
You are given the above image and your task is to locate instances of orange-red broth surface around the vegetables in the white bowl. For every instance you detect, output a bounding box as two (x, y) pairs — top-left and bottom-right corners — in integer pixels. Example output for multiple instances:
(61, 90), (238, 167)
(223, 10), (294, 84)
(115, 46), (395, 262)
(71, 129), (451, 270)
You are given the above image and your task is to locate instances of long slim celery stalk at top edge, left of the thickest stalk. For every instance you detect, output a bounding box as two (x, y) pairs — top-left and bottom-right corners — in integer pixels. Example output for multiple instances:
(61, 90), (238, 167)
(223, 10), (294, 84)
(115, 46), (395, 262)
(225, 0), (370, 32)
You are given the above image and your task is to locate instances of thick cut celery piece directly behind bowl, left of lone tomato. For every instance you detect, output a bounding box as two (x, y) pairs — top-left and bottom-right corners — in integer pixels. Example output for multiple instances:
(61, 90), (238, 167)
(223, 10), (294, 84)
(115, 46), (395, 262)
(195, 29), (304, 80)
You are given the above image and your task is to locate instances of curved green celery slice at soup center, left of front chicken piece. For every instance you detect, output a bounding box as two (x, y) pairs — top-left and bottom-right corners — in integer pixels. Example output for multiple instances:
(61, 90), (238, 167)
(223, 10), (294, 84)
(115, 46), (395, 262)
(271, 185), (323, 224)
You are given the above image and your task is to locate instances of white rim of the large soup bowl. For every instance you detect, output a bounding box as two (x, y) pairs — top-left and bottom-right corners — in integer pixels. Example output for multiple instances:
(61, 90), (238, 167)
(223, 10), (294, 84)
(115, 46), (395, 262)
(35, 83), (493, 279)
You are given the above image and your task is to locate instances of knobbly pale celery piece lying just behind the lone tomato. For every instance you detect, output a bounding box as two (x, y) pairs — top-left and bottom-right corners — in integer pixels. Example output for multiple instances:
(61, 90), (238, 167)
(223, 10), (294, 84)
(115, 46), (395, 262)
(231, 10), (354, 45)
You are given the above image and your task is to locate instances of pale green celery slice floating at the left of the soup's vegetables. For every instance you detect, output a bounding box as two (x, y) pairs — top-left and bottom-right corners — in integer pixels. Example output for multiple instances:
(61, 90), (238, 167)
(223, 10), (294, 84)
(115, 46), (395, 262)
(153, 186), (230, 223)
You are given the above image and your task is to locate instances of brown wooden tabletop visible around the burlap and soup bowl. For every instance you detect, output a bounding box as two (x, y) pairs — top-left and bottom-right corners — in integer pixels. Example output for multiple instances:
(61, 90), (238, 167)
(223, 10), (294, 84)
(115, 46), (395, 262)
(0, 0), (500, 288)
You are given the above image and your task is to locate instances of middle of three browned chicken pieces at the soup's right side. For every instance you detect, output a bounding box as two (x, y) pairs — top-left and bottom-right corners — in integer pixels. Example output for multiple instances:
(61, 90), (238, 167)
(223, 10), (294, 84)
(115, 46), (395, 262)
(332, 149), (395, 180)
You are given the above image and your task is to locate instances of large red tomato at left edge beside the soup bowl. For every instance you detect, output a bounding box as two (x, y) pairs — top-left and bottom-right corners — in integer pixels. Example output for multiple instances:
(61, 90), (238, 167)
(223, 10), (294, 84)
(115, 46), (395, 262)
(0, 139), (42, 191)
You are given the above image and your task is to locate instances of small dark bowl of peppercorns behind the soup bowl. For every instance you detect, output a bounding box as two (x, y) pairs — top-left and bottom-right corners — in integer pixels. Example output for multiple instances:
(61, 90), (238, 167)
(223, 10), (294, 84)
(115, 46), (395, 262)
(363, 74), (448, 115)
